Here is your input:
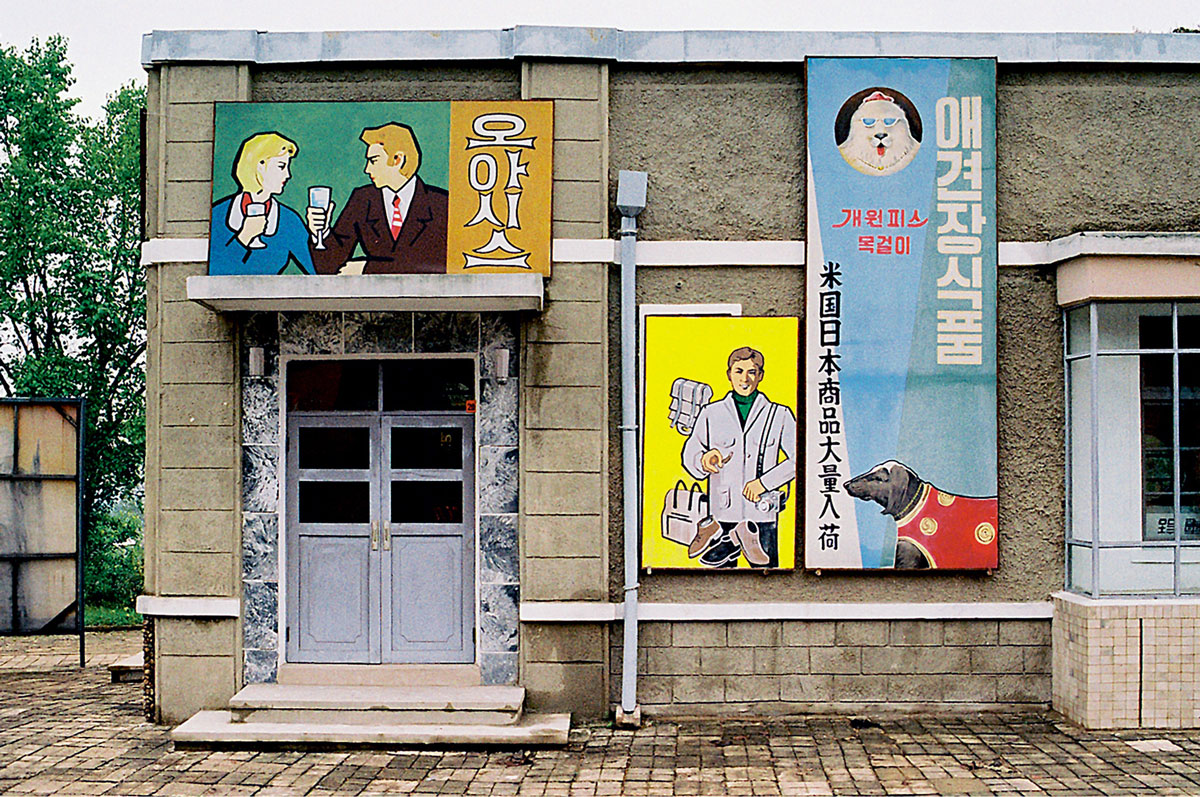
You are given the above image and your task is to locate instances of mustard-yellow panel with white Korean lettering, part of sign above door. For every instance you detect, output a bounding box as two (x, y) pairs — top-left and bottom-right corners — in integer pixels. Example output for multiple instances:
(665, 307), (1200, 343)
(446, 101), (554, 276)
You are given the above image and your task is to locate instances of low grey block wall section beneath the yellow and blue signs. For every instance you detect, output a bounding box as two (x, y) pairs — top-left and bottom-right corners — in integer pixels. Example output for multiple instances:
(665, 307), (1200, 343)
(611, 619), (1050, 714)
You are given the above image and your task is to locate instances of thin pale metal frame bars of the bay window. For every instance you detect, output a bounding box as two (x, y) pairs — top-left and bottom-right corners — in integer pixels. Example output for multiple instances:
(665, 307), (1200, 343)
(1062, 301), (1200, 598)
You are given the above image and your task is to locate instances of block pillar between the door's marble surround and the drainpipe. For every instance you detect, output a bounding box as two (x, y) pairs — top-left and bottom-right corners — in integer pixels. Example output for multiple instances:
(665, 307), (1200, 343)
(521, 62), (611, 717)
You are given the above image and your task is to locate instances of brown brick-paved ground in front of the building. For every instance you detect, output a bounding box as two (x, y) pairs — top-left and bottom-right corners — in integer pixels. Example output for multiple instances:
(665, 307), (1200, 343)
(0, 635), (1200, 796)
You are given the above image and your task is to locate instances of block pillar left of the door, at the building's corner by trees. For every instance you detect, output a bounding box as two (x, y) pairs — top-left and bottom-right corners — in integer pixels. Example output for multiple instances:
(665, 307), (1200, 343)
(145, 66), (248, 723)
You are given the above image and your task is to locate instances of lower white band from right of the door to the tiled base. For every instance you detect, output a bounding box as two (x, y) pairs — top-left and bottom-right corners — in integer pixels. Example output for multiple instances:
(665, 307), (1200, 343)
(520, 600), (1054, 623)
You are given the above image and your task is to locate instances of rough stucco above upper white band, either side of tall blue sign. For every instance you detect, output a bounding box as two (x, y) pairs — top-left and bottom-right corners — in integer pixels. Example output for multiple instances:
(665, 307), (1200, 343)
(610, 66), (1200, 240)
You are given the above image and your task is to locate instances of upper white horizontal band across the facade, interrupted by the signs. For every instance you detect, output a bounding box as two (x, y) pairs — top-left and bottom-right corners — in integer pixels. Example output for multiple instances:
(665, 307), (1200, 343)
(142, 232), (1200, 271)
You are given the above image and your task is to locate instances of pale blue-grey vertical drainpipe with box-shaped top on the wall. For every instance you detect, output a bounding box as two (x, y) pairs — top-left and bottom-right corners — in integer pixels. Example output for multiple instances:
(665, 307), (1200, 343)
(617, 169), (647, 727)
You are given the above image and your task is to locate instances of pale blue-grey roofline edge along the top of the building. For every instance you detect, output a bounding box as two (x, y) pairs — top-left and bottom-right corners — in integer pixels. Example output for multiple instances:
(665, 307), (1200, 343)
(142, 25), (1200, 68)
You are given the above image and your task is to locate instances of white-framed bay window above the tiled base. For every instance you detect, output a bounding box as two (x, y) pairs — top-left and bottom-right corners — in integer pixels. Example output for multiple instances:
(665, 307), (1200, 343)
(1064, 302), (1200, 598)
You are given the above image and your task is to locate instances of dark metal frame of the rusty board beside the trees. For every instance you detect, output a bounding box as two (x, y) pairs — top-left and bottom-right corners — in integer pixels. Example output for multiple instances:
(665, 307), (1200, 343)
(0, 399), (88, 667)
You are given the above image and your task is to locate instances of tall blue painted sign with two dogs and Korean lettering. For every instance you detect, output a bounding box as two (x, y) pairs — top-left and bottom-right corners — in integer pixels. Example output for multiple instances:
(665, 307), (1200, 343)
(804, 58), (998, 570)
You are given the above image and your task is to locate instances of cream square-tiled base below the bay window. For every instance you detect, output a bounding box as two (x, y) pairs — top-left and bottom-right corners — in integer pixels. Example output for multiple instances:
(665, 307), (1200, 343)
(1052, 592), (1200, 729)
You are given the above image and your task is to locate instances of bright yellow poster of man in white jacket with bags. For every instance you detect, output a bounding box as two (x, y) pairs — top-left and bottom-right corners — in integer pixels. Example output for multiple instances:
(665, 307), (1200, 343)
(642, 316), (799, 570)
